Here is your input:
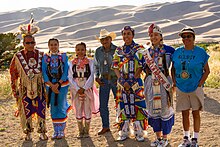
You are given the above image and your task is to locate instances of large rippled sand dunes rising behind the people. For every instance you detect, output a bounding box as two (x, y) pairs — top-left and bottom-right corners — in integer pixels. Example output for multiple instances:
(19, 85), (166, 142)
(0, 0), (220, 48)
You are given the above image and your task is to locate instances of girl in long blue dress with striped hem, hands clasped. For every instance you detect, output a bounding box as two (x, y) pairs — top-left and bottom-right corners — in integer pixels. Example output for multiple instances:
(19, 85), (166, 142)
(42, 38), (71, 139)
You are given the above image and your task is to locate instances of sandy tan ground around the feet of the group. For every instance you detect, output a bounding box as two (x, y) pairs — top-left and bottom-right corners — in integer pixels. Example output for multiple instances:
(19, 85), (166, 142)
(0, 88), (220, 147)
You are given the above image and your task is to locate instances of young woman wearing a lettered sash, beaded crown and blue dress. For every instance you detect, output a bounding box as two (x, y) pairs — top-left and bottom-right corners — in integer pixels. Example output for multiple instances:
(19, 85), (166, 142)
(144, 24), (175, 147)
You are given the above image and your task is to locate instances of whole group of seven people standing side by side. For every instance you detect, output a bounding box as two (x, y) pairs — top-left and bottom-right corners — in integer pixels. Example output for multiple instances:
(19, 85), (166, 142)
(10, 20), (210, 147)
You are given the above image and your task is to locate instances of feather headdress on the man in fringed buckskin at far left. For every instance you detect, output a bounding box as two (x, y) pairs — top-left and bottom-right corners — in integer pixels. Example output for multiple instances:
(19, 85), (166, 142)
(19, 13), (40, 38)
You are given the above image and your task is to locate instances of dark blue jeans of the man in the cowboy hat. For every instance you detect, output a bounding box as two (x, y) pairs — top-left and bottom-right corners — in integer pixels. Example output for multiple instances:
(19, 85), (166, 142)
(99, 78), (117, 128)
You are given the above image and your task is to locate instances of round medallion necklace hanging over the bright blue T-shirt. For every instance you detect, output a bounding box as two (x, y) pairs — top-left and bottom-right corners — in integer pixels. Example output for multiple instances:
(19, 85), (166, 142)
(180, 48), (194, 80)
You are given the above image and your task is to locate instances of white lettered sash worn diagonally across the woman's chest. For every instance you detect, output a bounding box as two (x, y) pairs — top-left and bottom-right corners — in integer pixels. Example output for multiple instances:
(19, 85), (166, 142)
(140, 49), (171, 91)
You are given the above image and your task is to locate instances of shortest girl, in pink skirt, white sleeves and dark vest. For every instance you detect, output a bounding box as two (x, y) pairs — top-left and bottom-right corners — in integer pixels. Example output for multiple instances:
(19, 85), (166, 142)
(68, 42), (99, 138)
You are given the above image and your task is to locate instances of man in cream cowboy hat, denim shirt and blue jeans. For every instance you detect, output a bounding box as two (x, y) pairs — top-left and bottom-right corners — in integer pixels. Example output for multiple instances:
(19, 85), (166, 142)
(94, 29), (117, 135)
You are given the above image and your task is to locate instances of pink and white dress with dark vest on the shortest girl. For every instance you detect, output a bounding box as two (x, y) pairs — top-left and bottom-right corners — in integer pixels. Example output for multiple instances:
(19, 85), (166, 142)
(68, 57), (99, 121)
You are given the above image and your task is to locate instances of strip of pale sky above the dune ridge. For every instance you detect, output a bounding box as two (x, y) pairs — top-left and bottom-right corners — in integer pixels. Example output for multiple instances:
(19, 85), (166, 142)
(0, 0), (200, 12)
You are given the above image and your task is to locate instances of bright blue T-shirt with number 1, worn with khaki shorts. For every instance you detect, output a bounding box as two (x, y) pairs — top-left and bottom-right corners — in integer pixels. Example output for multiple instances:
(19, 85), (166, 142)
(172, 46), (209, 93)
